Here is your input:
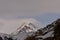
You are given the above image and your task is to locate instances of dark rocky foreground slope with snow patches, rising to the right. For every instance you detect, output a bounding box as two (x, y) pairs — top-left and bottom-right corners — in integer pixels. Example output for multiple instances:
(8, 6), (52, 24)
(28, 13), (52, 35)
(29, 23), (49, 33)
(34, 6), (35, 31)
(25, 19), (60, 40)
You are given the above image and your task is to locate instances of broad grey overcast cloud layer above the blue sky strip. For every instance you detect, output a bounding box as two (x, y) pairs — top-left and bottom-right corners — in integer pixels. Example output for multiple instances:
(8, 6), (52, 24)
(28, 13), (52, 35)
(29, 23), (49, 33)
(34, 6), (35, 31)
(0, 0), (60, 18)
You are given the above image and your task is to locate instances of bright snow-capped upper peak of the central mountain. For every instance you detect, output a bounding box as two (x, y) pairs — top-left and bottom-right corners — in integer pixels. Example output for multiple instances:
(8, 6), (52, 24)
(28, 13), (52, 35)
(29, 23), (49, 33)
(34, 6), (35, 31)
(12, 19), (42, 35)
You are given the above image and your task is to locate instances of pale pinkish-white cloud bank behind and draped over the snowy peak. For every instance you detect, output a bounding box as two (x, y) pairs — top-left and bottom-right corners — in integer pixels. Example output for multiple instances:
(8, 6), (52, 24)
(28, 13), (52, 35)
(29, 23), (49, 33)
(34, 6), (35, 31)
(0, 18), (42, 34)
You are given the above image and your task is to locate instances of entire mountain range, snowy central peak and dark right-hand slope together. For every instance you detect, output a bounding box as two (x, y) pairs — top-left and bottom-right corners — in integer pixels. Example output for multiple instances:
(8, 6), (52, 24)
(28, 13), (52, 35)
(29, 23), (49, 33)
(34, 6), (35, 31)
(0, 19), (60, 40)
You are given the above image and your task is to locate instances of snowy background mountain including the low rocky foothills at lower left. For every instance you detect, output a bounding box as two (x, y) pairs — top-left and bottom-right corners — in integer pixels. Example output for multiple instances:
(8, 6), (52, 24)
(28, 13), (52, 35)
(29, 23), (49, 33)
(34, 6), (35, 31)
(1, 18), (42, 40)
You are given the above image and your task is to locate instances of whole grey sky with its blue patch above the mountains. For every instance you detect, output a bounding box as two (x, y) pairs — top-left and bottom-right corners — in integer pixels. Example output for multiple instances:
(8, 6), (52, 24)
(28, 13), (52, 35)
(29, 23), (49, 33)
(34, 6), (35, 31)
(0, 0), (60, 33)
